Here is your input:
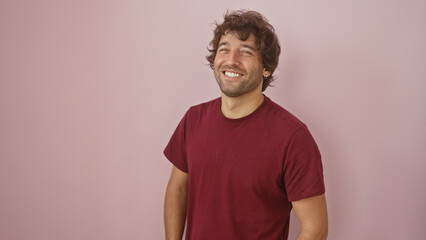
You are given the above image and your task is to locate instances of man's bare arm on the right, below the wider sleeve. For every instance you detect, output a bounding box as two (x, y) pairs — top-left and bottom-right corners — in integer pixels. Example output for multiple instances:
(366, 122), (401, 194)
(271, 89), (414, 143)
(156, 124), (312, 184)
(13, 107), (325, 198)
(292, 194), (328, 240)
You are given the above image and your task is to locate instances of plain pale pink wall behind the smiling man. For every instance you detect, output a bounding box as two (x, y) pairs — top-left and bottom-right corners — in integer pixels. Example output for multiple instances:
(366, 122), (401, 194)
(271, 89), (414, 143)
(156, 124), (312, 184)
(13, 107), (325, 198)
(0, 0), (426, 240)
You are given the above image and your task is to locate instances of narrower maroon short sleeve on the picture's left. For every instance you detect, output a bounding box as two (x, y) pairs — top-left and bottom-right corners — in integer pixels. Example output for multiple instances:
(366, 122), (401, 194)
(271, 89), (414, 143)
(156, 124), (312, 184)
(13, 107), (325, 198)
(163, 112), (188, 173)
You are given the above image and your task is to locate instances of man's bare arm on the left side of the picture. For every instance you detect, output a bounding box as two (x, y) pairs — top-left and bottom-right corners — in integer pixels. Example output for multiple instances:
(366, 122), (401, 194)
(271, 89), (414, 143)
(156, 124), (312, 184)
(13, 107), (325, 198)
(164, 166), (188, 240)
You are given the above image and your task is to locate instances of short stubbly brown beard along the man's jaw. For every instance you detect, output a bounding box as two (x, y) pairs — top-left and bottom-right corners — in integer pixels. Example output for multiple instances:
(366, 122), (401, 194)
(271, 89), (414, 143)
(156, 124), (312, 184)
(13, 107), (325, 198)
(214, 66), (263, 98)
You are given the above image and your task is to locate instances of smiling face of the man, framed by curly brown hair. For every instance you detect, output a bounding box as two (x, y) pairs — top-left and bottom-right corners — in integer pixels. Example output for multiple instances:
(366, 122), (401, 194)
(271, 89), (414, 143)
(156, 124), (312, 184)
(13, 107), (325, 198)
(214, 32), (270, 97)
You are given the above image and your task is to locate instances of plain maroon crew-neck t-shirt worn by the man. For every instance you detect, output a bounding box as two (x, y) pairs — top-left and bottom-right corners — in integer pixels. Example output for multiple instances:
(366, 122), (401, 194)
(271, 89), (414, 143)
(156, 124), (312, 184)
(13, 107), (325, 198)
(164, 96), (325, 240)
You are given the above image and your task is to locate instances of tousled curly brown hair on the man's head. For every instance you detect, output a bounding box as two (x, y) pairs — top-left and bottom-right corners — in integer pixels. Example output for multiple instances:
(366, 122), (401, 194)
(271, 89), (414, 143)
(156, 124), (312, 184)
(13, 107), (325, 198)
(206, 10), (281, 91)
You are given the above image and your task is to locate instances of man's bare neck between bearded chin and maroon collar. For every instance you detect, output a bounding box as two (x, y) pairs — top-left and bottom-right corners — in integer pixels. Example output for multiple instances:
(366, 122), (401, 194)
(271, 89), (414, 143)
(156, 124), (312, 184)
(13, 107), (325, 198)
(221, 92), (265, 119)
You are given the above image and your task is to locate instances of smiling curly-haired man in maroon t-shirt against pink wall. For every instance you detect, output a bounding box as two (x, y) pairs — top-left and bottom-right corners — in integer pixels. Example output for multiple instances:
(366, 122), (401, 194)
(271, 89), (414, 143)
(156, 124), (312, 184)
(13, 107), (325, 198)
(164, 11), (327, 240)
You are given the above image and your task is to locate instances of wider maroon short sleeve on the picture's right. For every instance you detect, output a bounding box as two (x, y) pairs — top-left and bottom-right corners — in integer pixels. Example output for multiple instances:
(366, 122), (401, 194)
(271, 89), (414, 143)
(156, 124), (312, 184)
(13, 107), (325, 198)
(283, 126), (325, 202)
